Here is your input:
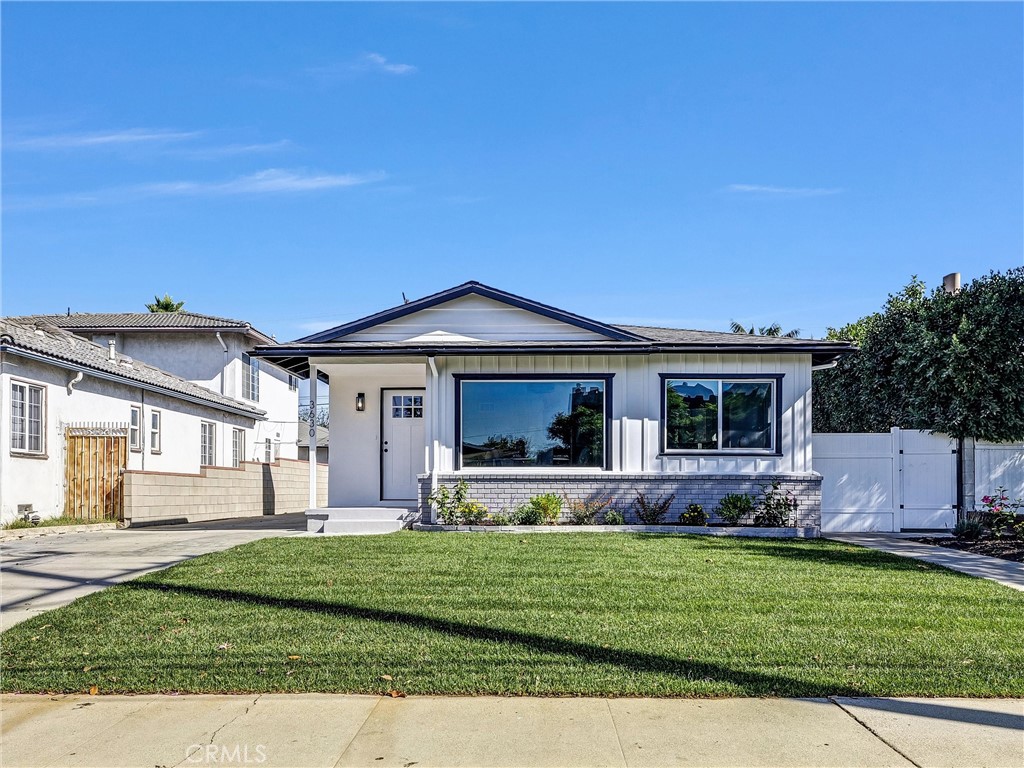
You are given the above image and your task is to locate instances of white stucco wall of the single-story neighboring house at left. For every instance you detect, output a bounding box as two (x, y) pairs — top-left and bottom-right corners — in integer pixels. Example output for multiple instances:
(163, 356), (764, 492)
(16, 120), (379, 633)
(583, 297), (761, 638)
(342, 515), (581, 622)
(0, 354), (256, 522)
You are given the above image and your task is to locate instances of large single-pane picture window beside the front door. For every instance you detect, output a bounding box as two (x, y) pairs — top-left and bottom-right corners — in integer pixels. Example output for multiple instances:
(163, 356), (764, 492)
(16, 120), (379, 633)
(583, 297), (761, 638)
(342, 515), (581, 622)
(456, 374), (611, 469)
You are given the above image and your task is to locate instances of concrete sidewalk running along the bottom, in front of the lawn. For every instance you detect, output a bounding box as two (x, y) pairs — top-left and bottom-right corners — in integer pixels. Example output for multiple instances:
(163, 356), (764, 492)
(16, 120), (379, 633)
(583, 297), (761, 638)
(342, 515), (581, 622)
(0, 694), (1024, 768)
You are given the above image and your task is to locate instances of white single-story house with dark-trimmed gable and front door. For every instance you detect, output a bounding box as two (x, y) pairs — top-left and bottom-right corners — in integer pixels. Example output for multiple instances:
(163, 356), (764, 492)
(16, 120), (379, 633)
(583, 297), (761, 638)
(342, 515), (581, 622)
(253, 282), (852, 526)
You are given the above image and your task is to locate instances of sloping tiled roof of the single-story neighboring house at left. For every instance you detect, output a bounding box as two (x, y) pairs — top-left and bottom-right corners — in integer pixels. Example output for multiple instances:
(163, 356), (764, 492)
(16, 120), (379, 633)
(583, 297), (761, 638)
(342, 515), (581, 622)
(0, 317), (266, 419)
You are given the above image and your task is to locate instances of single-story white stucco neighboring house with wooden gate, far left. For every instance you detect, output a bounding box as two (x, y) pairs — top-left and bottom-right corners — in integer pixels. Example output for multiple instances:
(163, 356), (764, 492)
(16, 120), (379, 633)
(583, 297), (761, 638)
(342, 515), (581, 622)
(0, 318), (265, 522)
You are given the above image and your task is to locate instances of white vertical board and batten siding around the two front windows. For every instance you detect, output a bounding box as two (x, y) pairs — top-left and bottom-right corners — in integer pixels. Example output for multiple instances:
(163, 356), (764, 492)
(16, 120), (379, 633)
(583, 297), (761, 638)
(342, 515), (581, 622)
(426, 354), (812, 474)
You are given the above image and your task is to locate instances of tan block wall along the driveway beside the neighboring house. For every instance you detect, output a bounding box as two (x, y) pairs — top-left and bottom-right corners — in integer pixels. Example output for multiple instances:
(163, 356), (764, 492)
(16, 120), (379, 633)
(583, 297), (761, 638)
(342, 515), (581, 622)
(125, 459), (328, 524)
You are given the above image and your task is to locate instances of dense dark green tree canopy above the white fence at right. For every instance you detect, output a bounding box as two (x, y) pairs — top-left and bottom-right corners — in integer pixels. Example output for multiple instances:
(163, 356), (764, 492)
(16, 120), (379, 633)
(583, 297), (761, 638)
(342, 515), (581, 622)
(813, 267), (1024, 441)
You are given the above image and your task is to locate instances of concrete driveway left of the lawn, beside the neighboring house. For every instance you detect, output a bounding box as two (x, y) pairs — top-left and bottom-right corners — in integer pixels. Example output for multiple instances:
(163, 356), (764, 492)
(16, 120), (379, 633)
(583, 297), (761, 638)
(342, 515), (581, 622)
(0, 512), (306, 630)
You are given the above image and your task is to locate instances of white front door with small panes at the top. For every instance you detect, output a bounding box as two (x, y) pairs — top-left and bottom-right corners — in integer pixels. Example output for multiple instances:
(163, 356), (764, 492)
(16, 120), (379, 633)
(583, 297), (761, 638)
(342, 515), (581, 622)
(381, 389), (427, 501)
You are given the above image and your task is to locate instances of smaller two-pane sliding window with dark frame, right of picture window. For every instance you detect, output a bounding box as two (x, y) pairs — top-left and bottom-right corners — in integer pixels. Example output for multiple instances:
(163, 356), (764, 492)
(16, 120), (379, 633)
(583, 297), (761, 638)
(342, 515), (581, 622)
(662, 374), (782, 454)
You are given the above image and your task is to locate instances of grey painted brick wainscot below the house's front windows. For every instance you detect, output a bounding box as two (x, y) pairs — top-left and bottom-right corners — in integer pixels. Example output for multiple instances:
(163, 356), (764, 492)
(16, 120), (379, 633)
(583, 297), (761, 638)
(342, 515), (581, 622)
(411, 473), (821, 527)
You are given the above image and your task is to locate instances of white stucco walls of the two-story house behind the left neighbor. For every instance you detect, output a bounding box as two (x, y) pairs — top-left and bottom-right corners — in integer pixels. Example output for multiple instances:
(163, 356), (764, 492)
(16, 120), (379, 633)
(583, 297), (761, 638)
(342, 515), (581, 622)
(90, 331), (299, 461)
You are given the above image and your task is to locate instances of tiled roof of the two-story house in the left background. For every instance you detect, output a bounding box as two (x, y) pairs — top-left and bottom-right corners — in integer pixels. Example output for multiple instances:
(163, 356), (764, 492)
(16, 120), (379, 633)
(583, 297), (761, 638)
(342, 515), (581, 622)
(10, 310), (274, 344)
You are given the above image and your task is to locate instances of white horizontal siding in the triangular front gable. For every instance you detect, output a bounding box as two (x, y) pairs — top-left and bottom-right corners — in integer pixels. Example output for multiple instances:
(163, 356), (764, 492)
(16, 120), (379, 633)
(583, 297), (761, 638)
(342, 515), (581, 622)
(345, 295), (608, 341)
